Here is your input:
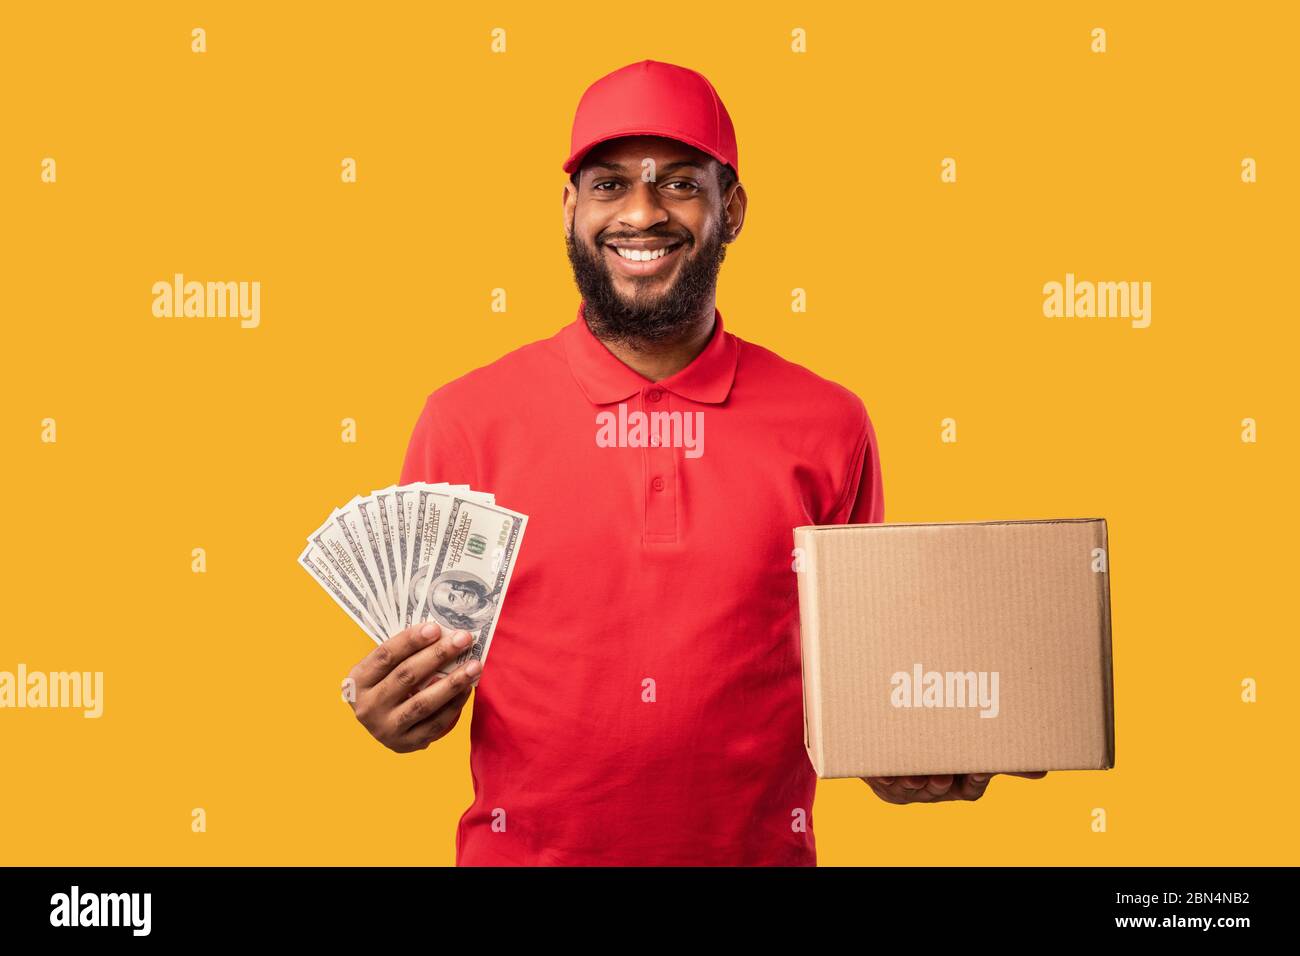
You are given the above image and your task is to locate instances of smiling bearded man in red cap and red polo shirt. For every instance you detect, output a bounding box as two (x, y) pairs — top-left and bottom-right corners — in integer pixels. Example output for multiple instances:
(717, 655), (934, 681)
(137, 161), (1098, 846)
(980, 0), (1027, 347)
(352, 60), (1041, 865)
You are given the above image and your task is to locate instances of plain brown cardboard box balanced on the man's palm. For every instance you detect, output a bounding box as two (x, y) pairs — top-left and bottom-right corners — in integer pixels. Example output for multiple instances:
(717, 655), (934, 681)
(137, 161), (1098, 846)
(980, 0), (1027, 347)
(794, 518), (1115, 777)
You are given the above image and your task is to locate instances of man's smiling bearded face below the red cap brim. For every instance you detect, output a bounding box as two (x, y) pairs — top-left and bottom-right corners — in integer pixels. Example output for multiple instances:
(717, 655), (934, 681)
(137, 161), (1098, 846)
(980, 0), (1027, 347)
(564, 137), (744, 342)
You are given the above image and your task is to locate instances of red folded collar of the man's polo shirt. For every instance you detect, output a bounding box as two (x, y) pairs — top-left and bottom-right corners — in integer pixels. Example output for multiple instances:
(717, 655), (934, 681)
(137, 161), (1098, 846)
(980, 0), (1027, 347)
(560, 302), (740, 405)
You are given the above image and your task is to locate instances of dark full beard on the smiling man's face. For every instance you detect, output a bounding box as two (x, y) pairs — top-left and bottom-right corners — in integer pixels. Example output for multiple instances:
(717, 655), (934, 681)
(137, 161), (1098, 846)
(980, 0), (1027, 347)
(566, 217), (727, 346)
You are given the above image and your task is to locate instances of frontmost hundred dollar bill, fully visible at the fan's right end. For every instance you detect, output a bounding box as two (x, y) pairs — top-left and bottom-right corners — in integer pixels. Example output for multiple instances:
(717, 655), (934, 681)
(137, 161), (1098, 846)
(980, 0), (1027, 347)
(417, 497), (528, 684)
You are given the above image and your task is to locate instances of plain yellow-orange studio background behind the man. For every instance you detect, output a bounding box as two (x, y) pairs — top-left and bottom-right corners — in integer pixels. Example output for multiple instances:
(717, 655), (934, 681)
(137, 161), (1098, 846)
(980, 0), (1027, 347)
(0, 3), (1300, 865)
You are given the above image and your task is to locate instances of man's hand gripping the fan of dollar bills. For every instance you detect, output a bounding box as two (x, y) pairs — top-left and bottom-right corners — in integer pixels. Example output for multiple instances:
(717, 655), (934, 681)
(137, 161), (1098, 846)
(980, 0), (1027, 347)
(348, 620), (482, 753)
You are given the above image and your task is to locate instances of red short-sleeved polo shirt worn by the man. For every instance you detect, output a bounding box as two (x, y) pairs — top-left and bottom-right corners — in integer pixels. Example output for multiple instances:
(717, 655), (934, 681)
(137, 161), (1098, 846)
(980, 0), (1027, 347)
(400, 307), (884, 866)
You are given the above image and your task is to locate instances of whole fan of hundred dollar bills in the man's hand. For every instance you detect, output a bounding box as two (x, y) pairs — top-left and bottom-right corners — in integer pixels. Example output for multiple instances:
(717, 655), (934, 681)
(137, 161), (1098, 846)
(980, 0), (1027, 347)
(298, 481), (528, 674)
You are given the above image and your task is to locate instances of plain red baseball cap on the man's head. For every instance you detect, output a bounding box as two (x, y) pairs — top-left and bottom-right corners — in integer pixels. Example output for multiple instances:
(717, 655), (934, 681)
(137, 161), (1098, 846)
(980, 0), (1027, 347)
(564, 60), (740, 178)
